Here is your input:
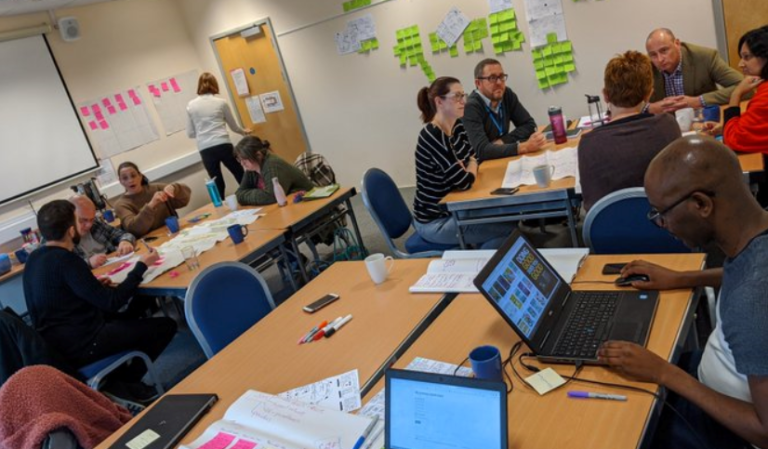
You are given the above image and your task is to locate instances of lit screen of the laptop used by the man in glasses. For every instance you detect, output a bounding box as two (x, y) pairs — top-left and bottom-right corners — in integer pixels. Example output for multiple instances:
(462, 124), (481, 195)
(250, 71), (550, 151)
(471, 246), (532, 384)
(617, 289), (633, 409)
(482, 234), (561, 339)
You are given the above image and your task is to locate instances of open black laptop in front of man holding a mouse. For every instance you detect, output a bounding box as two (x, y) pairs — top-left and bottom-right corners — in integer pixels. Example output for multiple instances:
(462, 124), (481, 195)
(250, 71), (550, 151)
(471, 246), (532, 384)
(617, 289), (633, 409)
(474, 231), (659, 363)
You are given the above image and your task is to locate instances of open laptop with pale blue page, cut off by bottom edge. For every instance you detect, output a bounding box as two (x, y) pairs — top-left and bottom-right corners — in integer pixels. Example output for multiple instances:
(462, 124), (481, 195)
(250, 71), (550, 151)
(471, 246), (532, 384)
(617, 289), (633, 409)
(384, 369), (507, 449)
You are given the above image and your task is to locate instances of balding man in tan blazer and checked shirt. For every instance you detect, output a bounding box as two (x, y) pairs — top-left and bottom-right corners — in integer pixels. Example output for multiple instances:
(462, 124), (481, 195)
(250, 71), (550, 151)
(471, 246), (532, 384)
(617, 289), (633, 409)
(645, 28), (742, 114)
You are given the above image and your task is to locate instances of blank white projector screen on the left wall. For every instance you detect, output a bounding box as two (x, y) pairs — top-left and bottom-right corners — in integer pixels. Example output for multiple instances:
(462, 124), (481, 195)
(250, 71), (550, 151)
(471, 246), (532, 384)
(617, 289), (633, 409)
(0, 35), (98, 204)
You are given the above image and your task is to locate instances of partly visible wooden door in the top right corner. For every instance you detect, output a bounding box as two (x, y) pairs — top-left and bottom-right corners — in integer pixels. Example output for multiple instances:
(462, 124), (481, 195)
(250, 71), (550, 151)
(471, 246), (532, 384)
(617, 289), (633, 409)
(722, 0), (768, 71)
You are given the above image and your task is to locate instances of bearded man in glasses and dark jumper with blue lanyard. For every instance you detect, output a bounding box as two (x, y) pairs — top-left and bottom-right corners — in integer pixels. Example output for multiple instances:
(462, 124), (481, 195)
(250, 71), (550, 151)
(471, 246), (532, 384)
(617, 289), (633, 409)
(462, 59), (547, 162)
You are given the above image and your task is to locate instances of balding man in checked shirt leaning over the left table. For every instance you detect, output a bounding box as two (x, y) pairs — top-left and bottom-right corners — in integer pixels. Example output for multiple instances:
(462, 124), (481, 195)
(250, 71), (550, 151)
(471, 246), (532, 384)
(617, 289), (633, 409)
(69, 195), (136, 268)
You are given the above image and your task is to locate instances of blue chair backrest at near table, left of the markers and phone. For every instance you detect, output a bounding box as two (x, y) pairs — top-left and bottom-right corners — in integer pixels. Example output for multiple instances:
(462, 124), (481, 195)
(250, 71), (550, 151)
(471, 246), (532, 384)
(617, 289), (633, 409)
(184, 262), (275, 359)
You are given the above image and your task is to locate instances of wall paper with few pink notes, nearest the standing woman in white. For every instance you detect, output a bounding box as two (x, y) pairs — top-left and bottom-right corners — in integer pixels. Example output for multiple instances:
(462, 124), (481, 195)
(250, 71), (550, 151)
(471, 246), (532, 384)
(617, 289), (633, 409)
(147, 70), (198, 136)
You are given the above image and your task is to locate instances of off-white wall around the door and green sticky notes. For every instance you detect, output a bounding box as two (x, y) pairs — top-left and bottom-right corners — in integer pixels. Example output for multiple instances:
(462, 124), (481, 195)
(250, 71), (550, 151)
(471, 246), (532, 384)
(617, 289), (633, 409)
(171, 0), (716, 185)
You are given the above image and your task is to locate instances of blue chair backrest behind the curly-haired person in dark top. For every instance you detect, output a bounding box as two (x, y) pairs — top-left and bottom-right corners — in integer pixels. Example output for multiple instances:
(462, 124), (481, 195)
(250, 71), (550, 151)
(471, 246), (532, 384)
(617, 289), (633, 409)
(583, 187), (690, 254)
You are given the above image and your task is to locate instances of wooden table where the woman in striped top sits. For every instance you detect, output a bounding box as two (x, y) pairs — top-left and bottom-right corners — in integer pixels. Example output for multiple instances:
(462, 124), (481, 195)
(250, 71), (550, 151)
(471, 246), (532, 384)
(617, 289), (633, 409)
(440, 131), (765, 248)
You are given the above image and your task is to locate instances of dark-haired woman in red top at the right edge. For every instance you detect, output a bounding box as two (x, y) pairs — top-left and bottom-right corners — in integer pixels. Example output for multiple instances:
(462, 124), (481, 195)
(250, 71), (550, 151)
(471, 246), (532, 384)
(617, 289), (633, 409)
(723, 26), (768, 154)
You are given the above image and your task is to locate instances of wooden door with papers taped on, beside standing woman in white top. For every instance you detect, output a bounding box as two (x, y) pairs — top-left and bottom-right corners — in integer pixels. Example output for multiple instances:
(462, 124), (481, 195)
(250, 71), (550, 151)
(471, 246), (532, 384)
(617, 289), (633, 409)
(213, 22), (308, 164)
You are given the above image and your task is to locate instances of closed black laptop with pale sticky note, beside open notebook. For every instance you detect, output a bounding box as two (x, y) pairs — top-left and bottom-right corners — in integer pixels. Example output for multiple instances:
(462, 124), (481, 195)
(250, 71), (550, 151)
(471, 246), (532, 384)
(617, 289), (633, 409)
(110, 394), (219, 449)
